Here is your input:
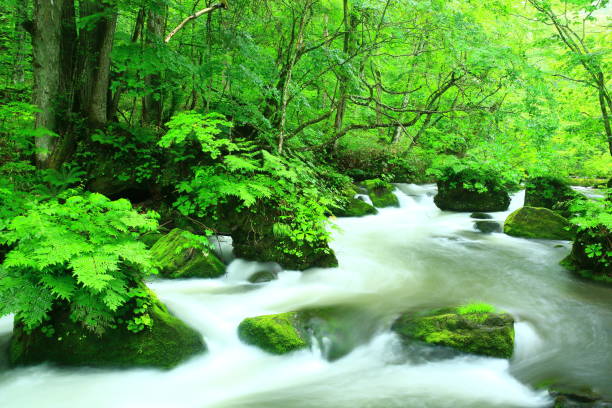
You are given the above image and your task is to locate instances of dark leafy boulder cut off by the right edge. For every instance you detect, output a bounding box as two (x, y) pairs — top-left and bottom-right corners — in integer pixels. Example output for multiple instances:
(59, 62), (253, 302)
(562, 225), (612, 283)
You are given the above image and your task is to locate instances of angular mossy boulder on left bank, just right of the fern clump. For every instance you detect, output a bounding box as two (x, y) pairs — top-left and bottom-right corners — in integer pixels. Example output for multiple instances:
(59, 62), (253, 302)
(151, 228), (225, 279)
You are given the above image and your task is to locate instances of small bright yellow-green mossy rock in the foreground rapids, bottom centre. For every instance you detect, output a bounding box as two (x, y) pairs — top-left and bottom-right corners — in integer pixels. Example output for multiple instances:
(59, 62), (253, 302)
(238, 312), (308, 354)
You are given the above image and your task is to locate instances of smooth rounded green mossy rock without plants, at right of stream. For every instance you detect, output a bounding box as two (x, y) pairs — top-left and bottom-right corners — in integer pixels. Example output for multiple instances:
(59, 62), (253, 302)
(504, 207), (574, 240)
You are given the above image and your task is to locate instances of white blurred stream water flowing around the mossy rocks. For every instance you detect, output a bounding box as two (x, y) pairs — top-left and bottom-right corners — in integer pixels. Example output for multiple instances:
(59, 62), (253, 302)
(0, 185), (612, 408)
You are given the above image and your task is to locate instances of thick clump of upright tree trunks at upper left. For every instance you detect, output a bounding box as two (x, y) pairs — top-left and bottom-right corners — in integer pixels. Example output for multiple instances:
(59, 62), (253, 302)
(32, 0), (117, 169)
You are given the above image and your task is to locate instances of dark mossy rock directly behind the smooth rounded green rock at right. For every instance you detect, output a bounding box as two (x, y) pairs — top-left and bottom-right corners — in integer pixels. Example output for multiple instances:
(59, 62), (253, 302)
(525, 177), (579, 210)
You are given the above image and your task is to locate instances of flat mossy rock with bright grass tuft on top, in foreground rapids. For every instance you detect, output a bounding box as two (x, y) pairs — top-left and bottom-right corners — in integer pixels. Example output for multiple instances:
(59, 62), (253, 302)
(392, 308), (514, 358)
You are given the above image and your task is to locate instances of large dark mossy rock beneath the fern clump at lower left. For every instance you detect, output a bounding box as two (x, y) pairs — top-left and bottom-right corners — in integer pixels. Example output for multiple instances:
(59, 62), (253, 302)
(9, 295), (206, 368)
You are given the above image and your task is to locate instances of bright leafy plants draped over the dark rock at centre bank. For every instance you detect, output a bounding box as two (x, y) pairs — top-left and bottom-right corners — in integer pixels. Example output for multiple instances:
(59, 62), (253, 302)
(160, 112), (334, 257)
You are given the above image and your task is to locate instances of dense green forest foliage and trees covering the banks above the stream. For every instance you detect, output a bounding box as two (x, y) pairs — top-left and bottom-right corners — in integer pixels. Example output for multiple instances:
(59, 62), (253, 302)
(0, 0), (612, 332)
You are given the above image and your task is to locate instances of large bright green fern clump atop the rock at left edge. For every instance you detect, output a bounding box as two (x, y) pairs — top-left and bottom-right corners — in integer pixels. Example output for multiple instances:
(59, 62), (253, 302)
(0, 190), (157, 333)
